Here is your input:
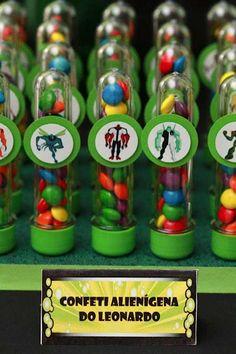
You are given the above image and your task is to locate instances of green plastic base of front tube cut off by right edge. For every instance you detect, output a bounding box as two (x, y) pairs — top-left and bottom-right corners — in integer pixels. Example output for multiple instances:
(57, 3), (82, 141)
(211, 230), (236, 261)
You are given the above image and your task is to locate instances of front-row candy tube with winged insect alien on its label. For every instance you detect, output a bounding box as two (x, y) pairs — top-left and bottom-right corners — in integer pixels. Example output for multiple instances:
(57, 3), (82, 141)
(24, 70), (79, 255)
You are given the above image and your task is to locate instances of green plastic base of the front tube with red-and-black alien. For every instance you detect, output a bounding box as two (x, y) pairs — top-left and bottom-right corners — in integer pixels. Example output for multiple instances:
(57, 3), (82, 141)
(92, 225), (136, 257)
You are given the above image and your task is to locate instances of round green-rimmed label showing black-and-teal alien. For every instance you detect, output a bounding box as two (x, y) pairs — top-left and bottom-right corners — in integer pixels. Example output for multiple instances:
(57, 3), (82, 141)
(142, 114), (198, 168)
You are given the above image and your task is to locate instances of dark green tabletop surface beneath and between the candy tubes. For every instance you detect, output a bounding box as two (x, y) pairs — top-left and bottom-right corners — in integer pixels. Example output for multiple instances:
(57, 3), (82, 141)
(0, 150), (236, 267)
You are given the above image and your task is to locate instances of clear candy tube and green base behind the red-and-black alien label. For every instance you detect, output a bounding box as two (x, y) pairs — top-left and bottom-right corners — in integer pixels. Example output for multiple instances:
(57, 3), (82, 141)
(92, 70), (135, 256)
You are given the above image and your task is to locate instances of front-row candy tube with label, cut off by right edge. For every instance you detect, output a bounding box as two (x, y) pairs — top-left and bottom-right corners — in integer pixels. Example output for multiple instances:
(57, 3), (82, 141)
(208, 75), (236, 260)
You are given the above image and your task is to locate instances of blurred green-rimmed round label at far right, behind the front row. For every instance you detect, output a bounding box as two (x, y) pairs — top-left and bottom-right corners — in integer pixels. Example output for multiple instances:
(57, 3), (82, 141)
(197, 43), (217, 89)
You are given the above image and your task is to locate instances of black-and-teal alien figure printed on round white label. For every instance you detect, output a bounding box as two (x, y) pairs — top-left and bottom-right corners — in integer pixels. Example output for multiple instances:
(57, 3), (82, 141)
(155, 124), (182, 162)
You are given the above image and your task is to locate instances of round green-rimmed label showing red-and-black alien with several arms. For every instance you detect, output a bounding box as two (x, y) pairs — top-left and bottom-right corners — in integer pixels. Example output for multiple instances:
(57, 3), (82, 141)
(88, 114), (142, 168)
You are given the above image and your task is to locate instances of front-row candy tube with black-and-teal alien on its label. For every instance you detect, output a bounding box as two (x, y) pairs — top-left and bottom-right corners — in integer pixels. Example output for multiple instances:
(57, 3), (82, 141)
(144, 73), (197, 259)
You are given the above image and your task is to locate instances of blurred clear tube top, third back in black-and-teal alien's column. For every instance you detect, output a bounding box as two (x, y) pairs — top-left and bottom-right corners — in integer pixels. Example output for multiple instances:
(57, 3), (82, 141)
(156, 19), (191, 50)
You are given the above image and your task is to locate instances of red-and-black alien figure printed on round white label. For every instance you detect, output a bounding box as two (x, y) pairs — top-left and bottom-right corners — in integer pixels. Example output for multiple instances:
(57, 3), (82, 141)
(105, 124), (130, 160)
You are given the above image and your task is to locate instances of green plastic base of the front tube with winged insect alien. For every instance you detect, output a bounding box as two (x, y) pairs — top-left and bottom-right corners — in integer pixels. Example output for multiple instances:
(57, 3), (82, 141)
(31, 225), (75, 256)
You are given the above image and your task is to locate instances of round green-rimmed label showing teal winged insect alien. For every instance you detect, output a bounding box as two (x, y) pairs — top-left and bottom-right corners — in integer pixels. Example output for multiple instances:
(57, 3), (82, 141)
(23, 116), (80, 168)
